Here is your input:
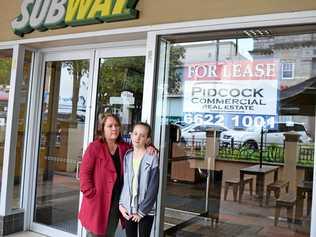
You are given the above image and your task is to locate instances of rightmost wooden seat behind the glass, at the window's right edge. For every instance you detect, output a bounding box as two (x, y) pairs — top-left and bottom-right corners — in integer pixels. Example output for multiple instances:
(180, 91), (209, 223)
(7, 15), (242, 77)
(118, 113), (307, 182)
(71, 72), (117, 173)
(295, 181), (313, 224)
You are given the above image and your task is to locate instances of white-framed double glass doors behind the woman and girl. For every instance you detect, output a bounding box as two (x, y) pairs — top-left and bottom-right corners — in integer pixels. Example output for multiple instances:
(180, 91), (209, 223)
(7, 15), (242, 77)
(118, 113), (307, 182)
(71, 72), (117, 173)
(31, 43), (145, 236)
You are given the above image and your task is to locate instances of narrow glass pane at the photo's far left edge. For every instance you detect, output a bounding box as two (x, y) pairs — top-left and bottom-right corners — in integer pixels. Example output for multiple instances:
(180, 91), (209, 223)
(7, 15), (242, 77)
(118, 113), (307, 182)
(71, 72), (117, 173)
(0, 49), (13, 196)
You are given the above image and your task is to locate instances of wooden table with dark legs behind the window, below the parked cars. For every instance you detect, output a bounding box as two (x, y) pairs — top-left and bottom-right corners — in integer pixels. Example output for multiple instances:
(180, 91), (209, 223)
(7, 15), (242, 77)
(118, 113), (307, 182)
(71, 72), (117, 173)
(239, 165), (279, 206)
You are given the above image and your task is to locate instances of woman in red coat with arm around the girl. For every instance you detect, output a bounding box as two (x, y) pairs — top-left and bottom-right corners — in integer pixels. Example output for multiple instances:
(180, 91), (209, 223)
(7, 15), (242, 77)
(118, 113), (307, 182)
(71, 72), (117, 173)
(79, 114), (131, 237)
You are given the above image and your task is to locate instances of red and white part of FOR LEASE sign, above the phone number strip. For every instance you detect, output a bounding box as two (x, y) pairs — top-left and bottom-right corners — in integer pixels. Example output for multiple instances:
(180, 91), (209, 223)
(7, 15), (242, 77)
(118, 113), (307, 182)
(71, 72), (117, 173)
(183, 61), (278, 115)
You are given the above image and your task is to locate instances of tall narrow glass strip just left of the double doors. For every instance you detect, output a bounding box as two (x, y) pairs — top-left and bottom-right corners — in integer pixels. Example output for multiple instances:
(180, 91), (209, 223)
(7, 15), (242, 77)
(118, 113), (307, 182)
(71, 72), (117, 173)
(12, 50), (33, 208)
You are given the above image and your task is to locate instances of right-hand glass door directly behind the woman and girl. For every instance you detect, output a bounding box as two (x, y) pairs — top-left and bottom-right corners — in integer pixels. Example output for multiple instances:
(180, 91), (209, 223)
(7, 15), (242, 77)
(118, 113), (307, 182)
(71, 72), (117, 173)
(83, 45), (145, 236)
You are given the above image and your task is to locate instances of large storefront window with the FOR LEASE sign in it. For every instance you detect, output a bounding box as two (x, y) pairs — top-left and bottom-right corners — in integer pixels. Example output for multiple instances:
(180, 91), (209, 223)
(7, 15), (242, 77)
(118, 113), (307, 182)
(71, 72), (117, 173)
(155, 28), (316, 236)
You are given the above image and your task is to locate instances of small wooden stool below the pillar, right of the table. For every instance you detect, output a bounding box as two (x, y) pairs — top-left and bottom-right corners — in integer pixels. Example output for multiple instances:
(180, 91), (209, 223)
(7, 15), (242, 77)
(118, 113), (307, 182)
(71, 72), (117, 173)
(274, 193), (296, 226)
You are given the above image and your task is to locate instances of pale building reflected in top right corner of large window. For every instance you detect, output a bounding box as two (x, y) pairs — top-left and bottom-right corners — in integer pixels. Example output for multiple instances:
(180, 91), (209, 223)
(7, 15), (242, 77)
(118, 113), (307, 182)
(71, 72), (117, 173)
(250, 33), (316, 88)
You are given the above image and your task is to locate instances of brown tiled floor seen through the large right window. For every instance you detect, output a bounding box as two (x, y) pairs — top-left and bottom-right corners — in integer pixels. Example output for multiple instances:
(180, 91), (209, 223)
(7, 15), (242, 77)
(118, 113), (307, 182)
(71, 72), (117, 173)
(165, 182), (310, 237)
